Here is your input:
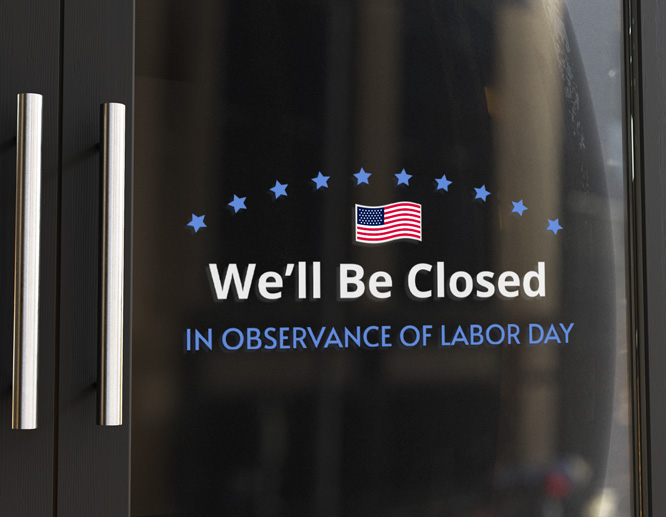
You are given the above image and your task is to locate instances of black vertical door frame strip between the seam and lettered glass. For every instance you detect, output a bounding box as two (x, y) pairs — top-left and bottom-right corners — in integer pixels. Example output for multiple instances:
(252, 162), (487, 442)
(55, 0), (134, 517)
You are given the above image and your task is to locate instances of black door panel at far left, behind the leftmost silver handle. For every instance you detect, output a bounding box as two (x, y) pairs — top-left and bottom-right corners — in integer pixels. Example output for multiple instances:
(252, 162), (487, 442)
(0, 0), (61, 516)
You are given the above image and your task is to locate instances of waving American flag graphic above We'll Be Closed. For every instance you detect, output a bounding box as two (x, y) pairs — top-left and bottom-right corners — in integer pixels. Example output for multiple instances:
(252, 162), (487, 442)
(356, 201), (421, 244)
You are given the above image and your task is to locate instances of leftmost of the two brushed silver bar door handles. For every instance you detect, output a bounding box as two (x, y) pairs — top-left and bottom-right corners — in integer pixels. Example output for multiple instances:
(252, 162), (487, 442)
(12, 93), (42, 429)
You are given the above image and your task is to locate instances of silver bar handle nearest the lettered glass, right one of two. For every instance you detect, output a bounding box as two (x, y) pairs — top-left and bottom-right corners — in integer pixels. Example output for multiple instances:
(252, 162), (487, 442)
(97, 102), (125, 425)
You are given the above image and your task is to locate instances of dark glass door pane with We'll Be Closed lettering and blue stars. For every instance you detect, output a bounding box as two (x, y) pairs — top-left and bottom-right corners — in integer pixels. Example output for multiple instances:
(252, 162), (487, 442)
(131, 0), (633, 517)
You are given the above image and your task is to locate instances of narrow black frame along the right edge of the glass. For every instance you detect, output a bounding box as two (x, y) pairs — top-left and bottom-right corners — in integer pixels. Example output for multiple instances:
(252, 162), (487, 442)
(626, 0), (666, 517)
